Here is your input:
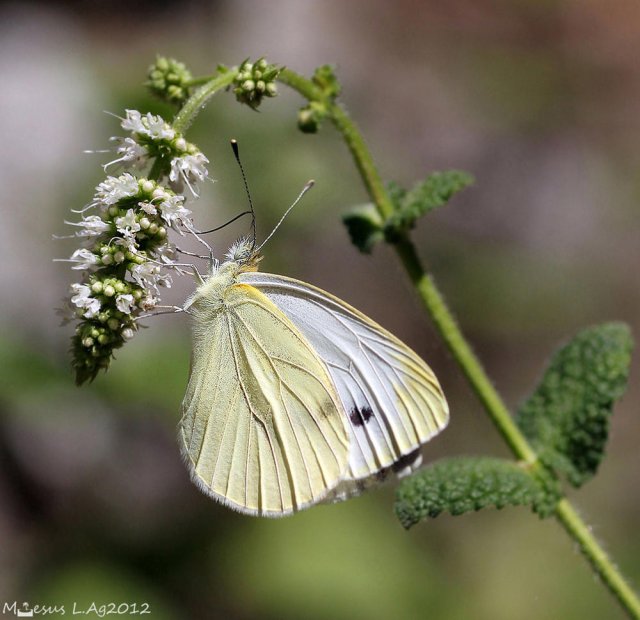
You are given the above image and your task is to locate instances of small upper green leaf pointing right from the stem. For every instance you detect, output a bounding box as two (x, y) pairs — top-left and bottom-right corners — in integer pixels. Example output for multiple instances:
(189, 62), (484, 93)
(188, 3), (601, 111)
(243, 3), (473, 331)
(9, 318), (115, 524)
(385, 170), (474, 242)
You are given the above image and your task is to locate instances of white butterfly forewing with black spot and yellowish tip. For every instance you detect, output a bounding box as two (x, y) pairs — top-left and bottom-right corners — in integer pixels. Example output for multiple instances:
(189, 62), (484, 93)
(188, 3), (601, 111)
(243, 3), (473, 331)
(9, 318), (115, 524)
(239, 272), (449, 499)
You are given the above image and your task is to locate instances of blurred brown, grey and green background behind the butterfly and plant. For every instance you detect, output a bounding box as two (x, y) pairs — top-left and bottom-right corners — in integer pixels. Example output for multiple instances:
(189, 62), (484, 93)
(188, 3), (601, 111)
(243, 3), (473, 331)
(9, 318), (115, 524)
(0, 0), (640, 620)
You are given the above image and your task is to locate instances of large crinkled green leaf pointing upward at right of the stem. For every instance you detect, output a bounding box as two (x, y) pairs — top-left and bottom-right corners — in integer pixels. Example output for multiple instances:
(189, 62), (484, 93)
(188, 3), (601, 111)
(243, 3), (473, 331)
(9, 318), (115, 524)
(518, 323), (633, 487)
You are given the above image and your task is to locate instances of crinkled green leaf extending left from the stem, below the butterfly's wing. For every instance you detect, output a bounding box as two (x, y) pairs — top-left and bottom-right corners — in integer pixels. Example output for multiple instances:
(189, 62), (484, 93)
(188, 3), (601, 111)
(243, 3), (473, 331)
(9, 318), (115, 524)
(395, 457), (559, 529)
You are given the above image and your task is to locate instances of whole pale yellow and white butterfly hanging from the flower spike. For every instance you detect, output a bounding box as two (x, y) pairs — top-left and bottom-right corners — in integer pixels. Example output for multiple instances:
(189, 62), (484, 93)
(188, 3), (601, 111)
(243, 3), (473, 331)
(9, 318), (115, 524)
(179, 241), (449, 517)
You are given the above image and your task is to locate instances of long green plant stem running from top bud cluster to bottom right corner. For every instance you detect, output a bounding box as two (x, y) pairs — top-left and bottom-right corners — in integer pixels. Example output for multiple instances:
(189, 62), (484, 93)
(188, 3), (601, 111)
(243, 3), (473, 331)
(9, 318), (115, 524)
(278, 69), (640, 620)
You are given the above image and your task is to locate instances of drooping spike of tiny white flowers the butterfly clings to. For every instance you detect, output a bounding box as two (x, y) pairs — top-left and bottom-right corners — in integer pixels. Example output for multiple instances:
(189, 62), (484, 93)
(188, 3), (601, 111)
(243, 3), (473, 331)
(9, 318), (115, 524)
(61, 110), (207, 384)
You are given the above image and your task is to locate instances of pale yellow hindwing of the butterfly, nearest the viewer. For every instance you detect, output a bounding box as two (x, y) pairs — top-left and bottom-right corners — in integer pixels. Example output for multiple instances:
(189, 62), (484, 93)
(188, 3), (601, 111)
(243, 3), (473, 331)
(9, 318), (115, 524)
(180, 284), (348, 516)
